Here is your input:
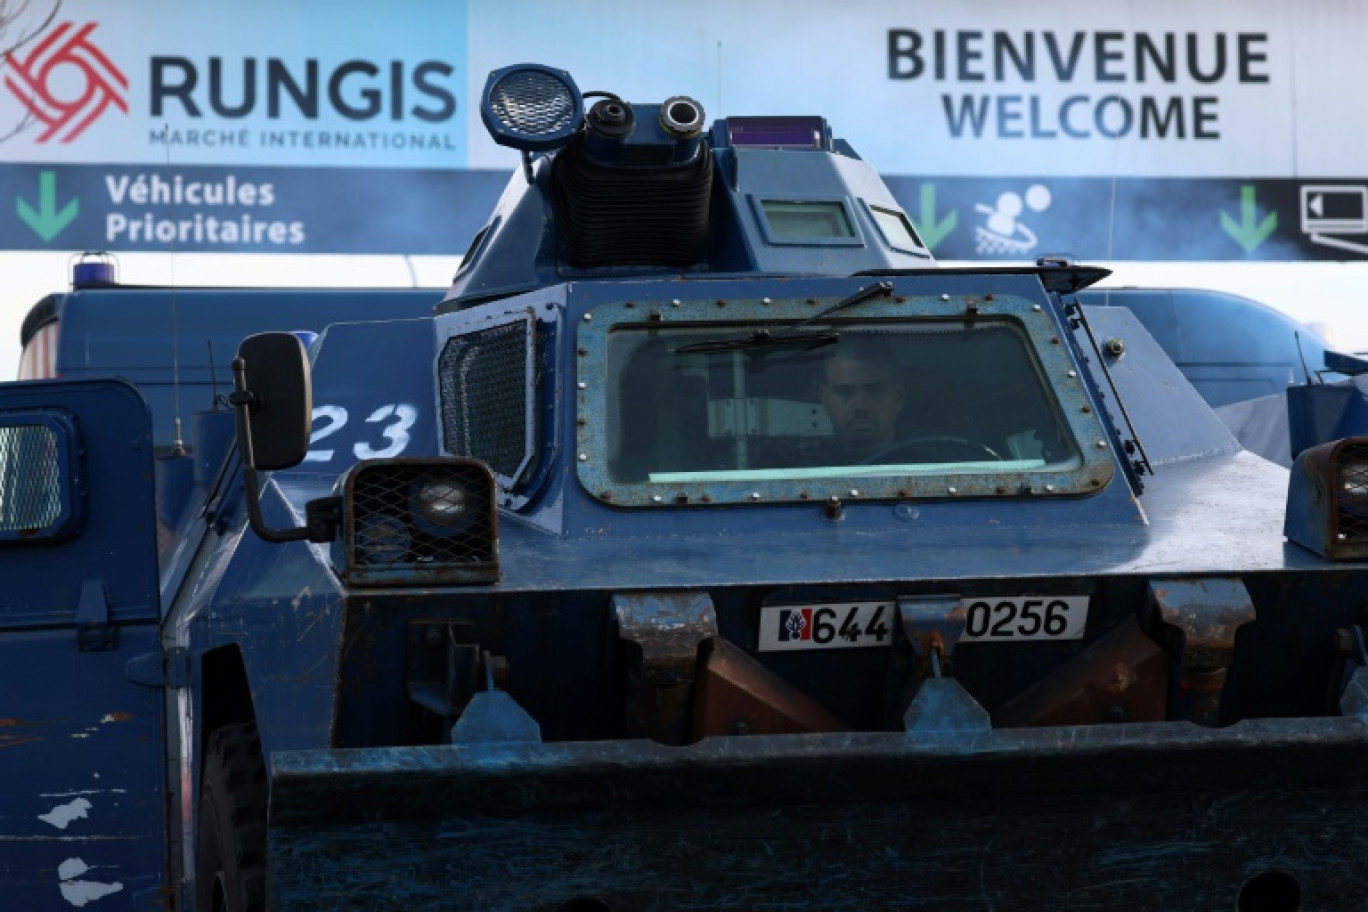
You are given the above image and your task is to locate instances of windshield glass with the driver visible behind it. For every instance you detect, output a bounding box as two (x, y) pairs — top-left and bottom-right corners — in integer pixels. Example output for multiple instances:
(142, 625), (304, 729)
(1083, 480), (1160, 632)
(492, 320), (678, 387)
(606, 319), (1081, 484)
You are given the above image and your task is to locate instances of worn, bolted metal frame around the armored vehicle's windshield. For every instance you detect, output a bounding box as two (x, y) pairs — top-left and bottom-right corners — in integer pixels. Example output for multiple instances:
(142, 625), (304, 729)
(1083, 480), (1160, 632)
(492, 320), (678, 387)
(576, 294), (1115, 507)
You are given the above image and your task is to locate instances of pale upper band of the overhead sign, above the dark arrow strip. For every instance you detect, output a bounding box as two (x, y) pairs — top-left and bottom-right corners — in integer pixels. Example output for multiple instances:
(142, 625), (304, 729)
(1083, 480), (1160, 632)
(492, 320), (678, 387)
(0, 0), (1368, 178)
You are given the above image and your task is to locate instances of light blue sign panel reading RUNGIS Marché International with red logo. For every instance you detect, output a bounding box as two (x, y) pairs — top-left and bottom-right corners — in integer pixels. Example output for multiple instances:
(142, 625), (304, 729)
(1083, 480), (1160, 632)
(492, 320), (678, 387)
(0, 0), (468, 168)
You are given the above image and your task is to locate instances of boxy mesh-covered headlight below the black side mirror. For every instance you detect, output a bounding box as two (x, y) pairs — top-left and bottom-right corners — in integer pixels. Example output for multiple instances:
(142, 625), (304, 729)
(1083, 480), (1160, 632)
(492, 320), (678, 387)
(342, 459), (499, 585)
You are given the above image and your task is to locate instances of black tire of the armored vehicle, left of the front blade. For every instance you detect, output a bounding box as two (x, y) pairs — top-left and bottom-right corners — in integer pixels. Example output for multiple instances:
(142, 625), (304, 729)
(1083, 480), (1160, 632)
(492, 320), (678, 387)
(194, 722), (267, 912)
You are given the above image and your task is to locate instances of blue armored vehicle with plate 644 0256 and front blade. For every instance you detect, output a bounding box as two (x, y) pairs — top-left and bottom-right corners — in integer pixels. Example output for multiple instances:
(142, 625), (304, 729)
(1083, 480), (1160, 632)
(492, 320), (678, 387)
(0, 64), (1368, 912)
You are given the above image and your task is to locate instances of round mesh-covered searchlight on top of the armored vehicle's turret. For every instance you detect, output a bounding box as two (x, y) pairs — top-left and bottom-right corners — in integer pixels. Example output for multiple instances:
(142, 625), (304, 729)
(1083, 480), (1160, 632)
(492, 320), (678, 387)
(480, 63), (584, 152)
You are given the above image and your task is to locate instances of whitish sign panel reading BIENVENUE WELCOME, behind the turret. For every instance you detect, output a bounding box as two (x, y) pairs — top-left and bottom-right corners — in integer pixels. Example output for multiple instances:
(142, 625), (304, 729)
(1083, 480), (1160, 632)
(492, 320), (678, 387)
(469, 0), (1368, 178)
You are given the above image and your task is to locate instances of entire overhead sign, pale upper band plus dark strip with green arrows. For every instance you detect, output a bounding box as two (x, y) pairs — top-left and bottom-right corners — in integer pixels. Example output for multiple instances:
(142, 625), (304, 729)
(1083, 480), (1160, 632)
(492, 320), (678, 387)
(0, 0), (1368, 260)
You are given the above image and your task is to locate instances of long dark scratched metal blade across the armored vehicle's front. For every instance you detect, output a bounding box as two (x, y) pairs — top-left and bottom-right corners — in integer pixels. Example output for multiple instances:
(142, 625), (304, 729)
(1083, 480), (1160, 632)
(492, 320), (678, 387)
(269, 716), (1368, 912)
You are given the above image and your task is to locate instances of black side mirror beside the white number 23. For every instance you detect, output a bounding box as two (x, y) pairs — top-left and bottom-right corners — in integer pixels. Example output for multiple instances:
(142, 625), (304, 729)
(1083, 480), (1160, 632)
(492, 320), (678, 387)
(233, 332), (313, 472)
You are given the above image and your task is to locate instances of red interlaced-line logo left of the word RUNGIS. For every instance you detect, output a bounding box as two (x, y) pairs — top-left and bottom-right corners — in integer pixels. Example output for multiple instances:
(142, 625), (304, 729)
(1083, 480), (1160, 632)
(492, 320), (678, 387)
(4, 22), (129, 142)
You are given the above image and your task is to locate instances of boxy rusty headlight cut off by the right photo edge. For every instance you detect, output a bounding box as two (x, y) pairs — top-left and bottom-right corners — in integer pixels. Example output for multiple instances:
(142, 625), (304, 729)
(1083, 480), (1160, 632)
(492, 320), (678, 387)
(1283, 438), (1368, 561)
